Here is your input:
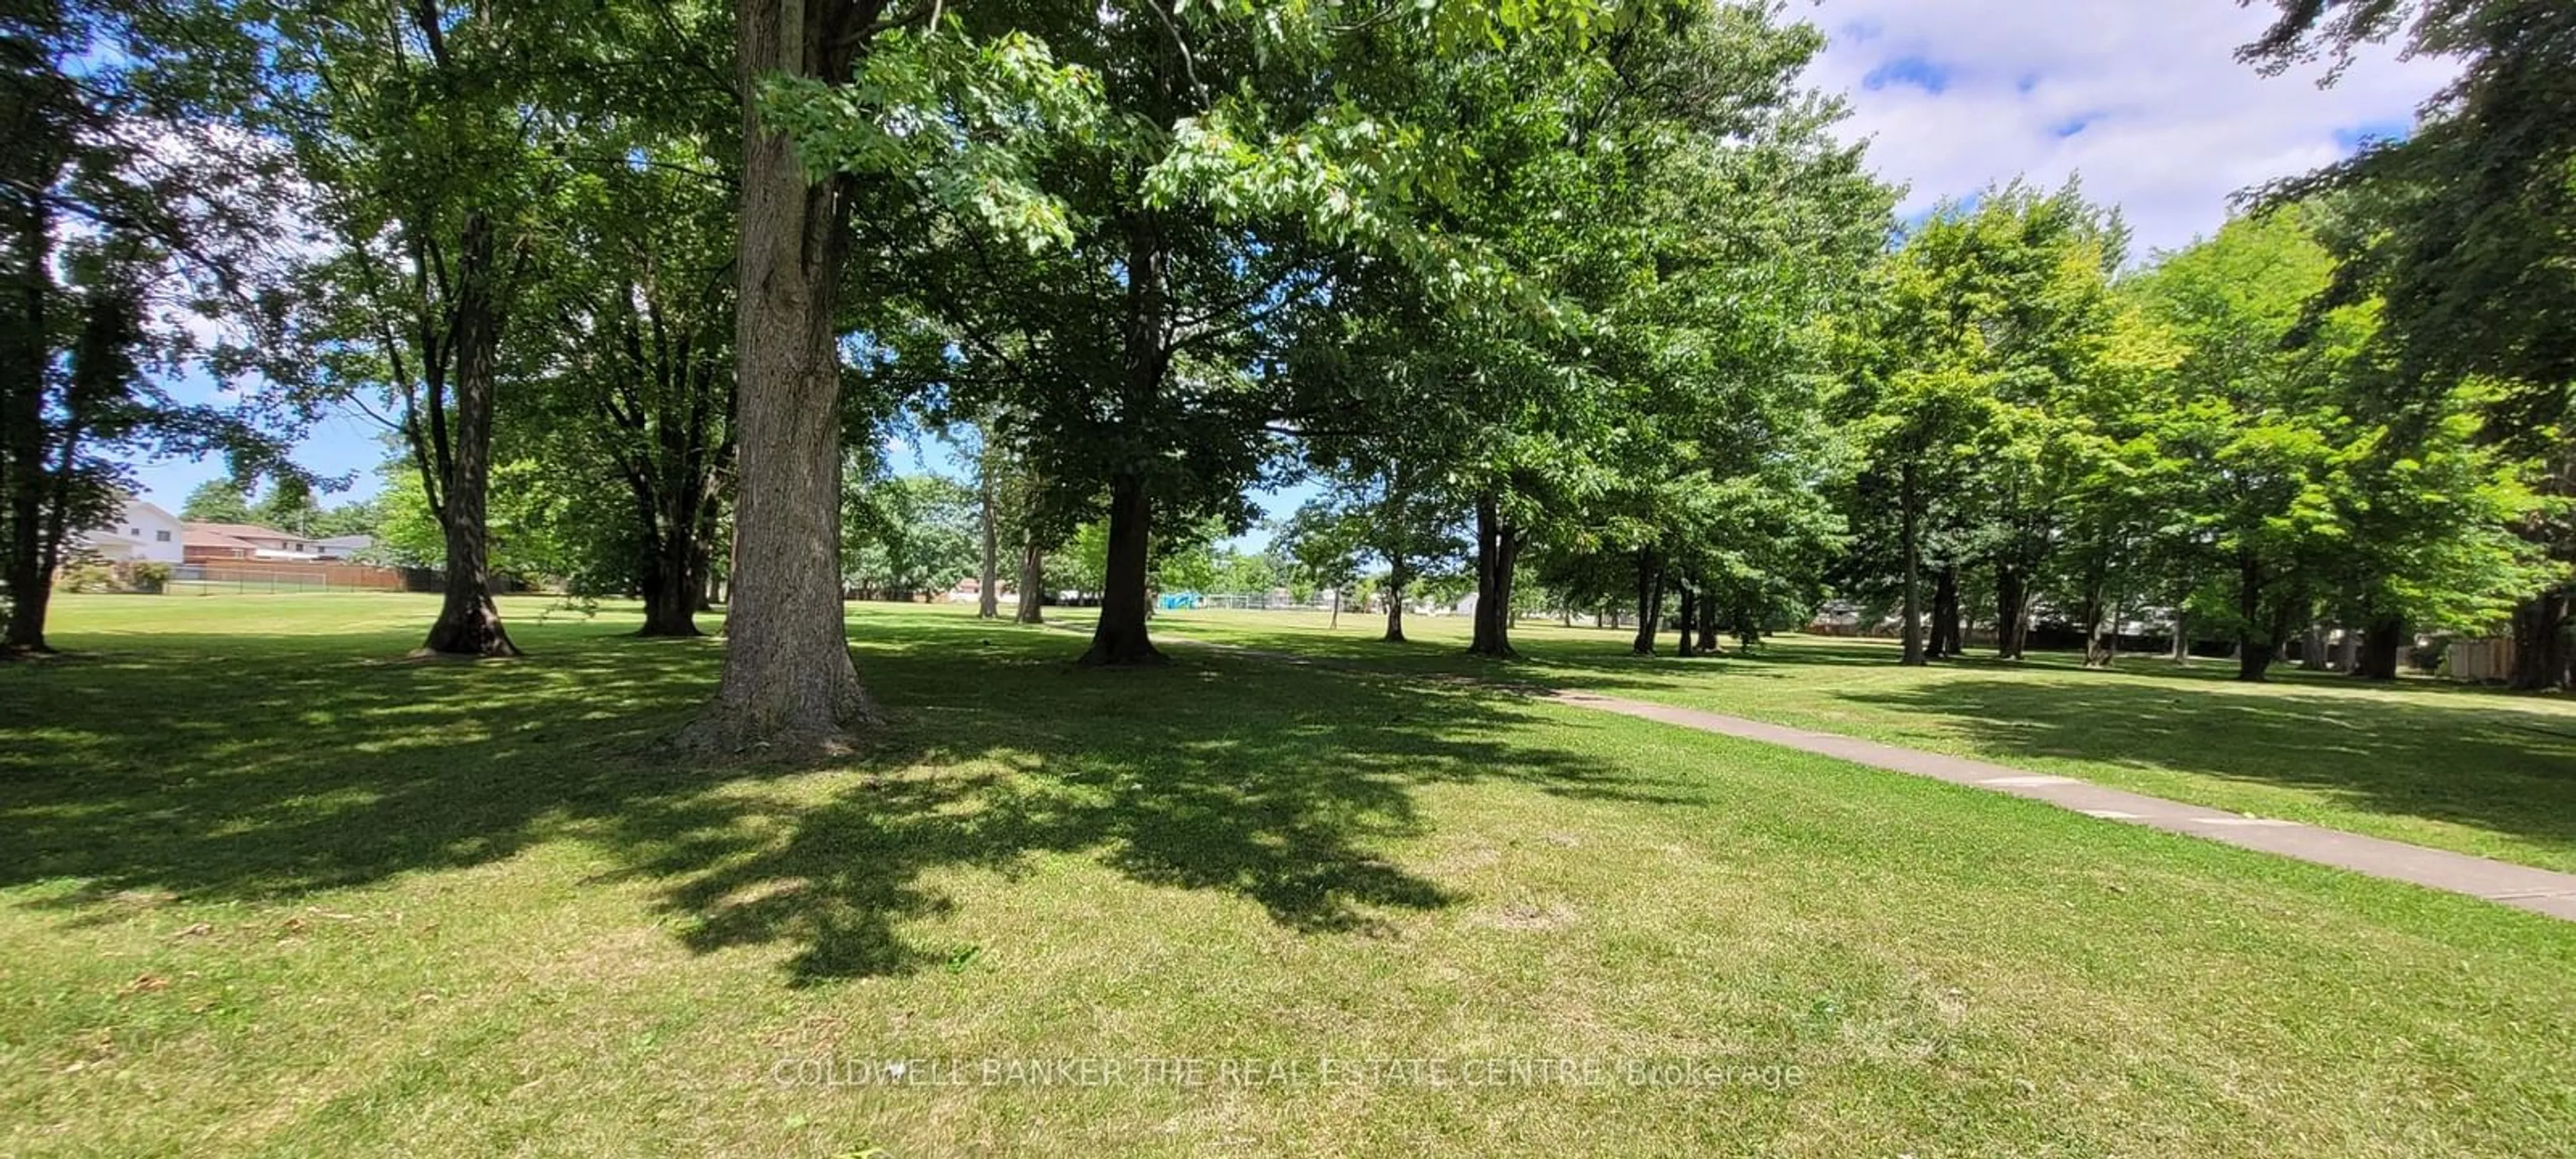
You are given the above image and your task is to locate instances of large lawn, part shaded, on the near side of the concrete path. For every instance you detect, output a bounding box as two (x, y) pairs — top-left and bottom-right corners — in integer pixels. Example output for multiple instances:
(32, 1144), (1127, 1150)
(0, 595), (2576, 1159)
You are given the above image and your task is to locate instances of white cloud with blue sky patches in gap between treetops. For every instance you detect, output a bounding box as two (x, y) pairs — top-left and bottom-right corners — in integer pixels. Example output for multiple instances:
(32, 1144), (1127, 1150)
(1793, 0), (2455, 258)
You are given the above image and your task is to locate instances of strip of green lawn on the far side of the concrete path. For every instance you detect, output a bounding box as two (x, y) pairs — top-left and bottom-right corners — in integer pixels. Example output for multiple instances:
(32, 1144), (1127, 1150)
(1133, 610), (2576, 871)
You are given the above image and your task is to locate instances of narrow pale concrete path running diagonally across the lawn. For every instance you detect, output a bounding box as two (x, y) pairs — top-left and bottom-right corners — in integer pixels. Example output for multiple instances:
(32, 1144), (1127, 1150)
(1546, 693), (2576, 922)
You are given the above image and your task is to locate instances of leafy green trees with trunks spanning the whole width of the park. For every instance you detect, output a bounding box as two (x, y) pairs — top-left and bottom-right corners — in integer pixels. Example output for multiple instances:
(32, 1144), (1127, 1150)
(0, 0), (2576, 747)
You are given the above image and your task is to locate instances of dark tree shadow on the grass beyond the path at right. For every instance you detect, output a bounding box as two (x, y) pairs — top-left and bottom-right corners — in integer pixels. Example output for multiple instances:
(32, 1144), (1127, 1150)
(1839, 675), (2576, 847)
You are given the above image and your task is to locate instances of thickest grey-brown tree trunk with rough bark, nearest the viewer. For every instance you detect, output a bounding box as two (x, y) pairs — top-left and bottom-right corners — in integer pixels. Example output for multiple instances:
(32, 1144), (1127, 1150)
(698, 0), (876, 749)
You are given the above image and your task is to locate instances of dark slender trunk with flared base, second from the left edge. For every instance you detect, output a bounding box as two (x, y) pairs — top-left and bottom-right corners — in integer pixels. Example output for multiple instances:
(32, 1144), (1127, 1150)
(423, 214), (518, 657)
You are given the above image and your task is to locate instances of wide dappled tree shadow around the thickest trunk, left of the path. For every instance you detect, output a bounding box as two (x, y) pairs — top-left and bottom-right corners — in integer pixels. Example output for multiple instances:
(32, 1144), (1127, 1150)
(0, 620), (1638, 984)
